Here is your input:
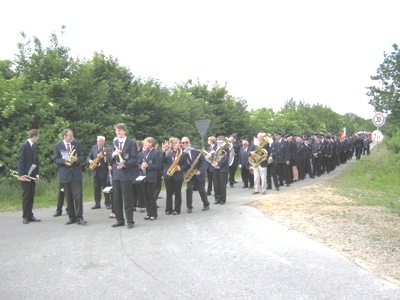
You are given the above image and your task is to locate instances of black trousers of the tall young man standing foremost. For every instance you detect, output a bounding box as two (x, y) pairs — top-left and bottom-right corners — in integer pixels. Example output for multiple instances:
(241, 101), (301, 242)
(113, 180), (134, 224)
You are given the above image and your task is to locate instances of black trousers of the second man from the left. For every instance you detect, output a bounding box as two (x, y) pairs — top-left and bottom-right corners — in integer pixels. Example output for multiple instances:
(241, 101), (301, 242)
(63, 180), (83, 220)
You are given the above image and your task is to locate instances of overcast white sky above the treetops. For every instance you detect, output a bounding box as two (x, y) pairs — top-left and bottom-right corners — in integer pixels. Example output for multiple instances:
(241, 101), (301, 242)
(0, 0), (400, 118)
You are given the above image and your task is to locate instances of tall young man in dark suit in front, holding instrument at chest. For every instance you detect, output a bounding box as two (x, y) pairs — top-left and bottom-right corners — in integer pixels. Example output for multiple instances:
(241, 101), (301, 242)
(110, 123), (138, 228)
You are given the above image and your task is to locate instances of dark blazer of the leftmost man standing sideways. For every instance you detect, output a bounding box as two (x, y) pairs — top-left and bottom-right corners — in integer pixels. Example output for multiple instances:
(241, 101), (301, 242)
(17, 141), (39, 177)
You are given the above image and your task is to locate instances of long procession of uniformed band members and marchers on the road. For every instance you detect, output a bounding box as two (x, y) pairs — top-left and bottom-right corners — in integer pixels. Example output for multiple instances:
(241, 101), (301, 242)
(18, 123), (369, 228)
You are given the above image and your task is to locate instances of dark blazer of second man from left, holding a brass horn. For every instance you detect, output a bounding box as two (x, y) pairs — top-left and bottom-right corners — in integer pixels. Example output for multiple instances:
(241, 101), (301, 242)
(53, 141), (85, 183)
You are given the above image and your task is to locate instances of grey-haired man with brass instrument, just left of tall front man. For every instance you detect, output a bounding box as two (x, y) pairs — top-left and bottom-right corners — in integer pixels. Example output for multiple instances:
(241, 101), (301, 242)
(87, 135), (111, 209)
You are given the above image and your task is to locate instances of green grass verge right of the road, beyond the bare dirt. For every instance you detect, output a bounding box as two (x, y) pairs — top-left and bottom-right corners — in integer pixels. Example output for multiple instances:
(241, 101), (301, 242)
(330, 144), (400, 214)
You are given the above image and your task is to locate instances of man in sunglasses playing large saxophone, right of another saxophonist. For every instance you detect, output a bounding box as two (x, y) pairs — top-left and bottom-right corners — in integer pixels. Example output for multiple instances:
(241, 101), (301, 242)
(181, 137), (210, 213)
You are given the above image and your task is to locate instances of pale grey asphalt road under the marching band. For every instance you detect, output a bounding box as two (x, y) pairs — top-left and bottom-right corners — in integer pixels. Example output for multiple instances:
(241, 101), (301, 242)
(0, 161), (400, 300)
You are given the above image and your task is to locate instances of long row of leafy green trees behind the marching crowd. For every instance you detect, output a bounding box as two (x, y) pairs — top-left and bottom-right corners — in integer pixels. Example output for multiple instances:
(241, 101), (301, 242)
(0, 27), (371, 179)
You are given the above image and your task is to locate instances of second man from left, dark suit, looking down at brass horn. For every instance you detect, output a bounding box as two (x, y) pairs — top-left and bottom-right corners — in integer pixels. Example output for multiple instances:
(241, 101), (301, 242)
(53, 129), (86, 225)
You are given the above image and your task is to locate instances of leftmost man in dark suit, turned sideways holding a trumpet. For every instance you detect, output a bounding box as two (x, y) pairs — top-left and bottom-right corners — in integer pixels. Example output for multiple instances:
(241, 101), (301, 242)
(18, 129), (40, 224)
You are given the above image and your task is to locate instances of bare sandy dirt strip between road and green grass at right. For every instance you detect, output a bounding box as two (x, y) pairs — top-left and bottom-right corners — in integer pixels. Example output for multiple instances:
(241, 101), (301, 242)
(252, 182), (400, 286)
